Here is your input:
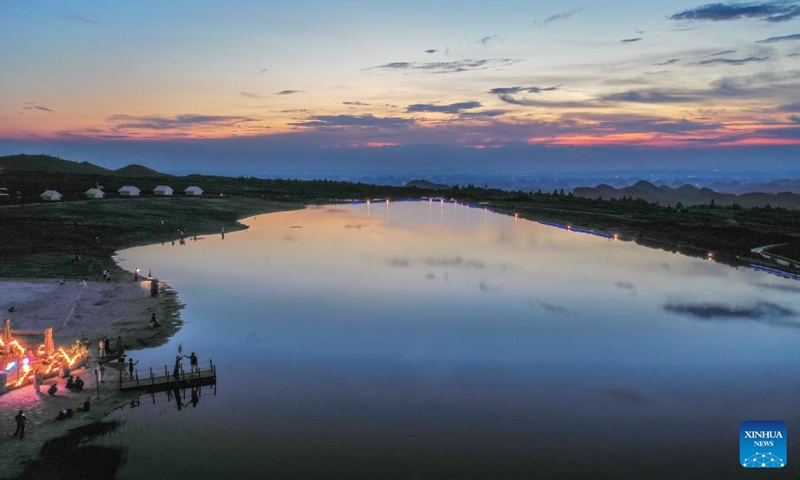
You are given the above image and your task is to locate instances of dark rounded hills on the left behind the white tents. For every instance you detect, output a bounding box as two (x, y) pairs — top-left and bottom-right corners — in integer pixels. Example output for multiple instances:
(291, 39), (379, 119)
(0, 153), (171, 177)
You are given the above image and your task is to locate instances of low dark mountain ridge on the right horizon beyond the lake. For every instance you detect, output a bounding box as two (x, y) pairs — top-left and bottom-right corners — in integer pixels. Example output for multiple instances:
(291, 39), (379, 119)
(572, 180), (800, 209)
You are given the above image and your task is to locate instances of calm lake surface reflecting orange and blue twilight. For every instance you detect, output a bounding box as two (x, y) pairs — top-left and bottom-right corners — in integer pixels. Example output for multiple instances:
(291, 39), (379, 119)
(104, 202), (800, 479)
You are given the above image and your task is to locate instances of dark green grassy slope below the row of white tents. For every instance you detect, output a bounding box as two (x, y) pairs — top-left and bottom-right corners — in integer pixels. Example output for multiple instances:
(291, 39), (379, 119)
(0, 197), (303, 279)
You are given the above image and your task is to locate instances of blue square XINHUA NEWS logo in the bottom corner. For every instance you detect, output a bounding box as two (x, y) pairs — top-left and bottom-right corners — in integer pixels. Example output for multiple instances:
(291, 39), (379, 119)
(739, 421), (786, 468)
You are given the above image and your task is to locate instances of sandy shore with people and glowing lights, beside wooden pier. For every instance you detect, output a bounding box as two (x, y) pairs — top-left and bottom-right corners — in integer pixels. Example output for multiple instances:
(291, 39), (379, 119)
(0, 278), (182, 478)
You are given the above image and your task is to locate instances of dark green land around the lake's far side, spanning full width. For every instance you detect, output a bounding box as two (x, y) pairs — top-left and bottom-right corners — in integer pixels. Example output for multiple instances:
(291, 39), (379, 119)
(0, 157), (800, 278)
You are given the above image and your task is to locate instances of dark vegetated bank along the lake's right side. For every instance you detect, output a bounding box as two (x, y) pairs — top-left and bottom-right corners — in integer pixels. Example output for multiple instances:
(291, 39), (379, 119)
(458, 187), (800, 264)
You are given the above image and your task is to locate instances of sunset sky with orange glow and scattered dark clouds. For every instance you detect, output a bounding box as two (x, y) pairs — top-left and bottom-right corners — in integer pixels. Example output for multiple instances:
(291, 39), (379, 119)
(0, 0), (800, 170)
